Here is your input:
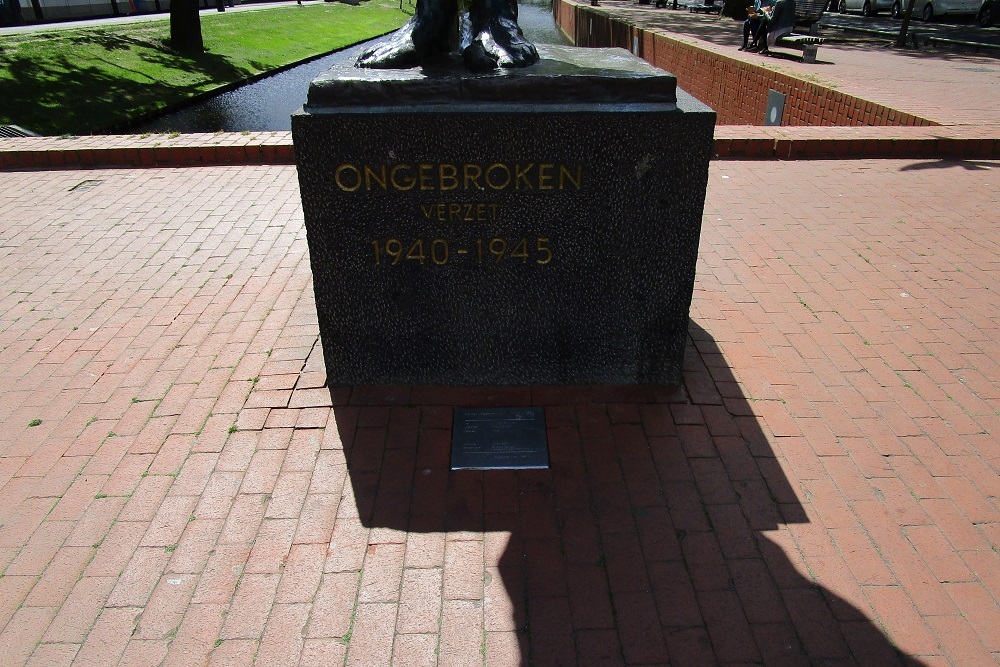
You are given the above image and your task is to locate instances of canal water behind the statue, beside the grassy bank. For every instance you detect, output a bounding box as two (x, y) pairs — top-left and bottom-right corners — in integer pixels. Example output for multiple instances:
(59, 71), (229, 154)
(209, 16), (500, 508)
(132, 0), (569, 133)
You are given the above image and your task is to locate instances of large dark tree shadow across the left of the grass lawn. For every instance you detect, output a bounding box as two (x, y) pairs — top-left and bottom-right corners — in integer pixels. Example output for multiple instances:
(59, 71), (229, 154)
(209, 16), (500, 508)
(0, 31), (253, 135)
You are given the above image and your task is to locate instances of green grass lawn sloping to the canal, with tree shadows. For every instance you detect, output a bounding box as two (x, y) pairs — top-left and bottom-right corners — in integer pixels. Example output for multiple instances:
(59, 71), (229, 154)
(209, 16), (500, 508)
(0, 0), (412, 135)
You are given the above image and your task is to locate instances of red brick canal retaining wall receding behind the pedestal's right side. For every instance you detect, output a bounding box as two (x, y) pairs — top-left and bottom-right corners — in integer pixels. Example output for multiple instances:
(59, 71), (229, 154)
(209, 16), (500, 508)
(553, 0), (938, 127)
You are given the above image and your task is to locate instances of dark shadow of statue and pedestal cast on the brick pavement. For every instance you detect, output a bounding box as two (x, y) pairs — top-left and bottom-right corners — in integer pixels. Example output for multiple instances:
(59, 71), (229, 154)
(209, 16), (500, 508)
(332, 322), (921, 665)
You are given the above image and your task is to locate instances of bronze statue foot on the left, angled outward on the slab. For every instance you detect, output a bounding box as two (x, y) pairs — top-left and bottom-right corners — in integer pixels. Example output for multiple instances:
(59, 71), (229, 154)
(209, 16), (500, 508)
(355, 0), (458, 69)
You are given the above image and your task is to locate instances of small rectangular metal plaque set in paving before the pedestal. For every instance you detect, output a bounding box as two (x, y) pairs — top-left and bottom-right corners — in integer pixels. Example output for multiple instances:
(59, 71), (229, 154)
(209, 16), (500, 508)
(451, 408), (549, 470)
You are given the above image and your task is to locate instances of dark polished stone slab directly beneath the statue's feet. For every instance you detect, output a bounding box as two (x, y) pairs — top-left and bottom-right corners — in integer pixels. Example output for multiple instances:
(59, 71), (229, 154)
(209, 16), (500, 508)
(305, 45), (677, 112)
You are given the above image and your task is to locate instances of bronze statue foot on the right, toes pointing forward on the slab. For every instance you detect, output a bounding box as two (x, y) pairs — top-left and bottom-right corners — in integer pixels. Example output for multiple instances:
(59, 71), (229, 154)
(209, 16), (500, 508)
(464, 0), (538, 72)
